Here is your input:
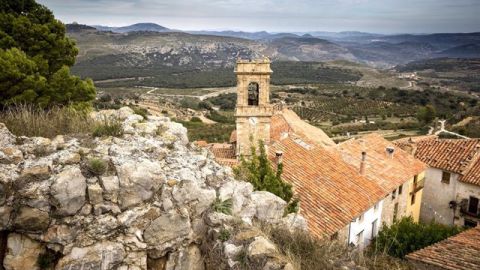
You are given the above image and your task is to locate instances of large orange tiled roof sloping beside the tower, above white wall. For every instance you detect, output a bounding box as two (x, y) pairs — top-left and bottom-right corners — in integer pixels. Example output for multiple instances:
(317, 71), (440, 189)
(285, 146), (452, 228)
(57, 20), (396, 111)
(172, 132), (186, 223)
(269, 136), (386, 237)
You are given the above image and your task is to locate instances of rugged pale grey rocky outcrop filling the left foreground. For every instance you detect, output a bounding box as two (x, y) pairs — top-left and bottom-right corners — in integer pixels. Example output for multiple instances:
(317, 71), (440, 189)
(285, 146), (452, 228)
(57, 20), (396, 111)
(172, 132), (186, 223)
(0, 108), (306, 270)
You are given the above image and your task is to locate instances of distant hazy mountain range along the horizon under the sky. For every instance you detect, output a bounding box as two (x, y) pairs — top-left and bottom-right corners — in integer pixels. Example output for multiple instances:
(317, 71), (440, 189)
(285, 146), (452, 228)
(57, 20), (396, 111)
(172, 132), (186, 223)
(67, 23), (480, 78)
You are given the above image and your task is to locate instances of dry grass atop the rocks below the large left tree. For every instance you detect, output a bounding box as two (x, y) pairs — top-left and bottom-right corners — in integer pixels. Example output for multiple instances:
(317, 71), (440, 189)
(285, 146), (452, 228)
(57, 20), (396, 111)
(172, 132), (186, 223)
(0, 105), (94, 138)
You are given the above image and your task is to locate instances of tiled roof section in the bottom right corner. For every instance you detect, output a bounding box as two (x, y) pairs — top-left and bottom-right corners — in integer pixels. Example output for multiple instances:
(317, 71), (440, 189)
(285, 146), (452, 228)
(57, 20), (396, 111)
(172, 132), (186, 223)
(407, 227), (480, 270)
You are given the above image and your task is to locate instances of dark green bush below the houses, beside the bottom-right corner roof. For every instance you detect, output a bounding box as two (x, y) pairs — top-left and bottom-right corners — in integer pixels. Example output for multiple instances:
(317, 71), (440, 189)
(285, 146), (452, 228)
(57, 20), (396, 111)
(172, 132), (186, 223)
(372, 217), (462, 258)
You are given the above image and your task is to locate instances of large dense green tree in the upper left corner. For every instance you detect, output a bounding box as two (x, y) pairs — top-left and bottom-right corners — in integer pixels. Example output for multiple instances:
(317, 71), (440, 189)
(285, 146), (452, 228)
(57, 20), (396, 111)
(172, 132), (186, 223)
(0, 0), (95, 107)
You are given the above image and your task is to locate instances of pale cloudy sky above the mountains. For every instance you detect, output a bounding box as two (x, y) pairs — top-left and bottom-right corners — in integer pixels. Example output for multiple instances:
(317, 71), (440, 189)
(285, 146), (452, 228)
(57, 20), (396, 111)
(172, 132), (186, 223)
(37, 0), (480, 33)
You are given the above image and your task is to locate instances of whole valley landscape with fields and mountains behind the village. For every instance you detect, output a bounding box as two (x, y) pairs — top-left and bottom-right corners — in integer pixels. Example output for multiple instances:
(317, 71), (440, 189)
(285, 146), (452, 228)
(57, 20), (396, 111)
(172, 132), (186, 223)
(67, 24), (480, 142)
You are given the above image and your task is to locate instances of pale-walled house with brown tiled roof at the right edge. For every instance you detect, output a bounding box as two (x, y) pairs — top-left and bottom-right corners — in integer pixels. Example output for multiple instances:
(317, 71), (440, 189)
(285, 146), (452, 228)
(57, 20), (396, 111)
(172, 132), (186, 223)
(397, 136), (480, 227)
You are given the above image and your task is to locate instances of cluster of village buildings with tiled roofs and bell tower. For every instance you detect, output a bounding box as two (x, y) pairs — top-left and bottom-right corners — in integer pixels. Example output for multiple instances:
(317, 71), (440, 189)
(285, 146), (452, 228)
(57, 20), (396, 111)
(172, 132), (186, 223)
(203, 59), (480, 269)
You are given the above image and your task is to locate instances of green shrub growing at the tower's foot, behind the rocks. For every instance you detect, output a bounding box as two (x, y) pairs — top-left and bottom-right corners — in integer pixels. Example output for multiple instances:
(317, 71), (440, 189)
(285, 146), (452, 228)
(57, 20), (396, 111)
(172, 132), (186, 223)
(234, 141), (299, 213)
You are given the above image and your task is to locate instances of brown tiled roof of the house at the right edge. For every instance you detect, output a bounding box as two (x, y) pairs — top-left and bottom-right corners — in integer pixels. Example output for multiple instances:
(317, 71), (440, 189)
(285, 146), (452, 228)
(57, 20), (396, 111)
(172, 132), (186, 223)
(415, 139), (480, 174)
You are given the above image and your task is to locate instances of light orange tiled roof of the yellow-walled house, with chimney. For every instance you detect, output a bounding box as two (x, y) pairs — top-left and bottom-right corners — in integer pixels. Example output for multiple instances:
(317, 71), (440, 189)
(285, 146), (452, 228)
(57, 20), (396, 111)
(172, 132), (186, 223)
(337, 133), (426, 192)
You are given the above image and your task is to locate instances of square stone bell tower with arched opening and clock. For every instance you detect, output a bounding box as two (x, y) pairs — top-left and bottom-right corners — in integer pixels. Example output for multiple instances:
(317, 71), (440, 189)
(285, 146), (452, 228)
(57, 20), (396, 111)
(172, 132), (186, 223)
(235, 58), (273, 156)
